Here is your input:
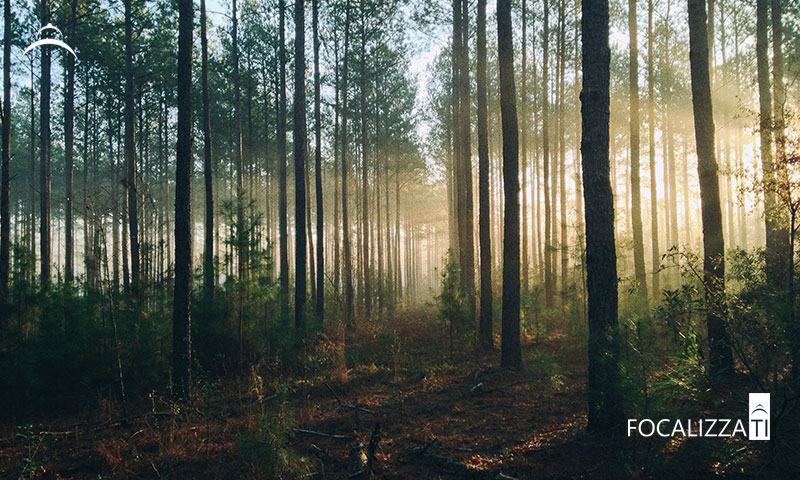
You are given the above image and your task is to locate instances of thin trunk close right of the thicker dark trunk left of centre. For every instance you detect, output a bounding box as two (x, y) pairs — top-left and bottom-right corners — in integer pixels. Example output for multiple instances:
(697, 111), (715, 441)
(311, 0), (325, 324)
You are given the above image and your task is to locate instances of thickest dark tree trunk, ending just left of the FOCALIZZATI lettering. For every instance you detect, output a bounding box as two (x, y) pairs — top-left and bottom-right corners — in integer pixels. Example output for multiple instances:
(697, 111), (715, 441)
(581, 0), (623, 431)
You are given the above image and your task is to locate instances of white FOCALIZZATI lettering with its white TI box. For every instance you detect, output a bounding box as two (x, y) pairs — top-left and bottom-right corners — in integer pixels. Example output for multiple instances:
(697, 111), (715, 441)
(628, 393), (770, 440)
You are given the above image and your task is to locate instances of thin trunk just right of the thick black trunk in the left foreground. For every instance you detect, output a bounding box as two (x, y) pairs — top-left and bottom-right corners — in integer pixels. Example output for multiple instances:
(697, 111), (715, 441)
(200, 0), (216, 299)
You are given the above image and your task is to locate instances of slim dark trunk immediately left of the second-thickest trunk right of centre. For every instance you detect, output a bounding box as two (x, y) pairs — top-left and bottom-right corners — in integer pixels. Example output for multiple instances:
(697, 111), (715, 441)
(475, 0), (494, 348)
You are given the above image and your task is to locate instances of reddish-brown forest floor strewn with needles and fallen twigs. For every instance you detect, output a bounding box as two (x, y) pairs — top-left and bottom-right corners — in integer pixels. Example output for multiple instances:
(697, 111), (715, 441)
(0, 309), (780, 479)
